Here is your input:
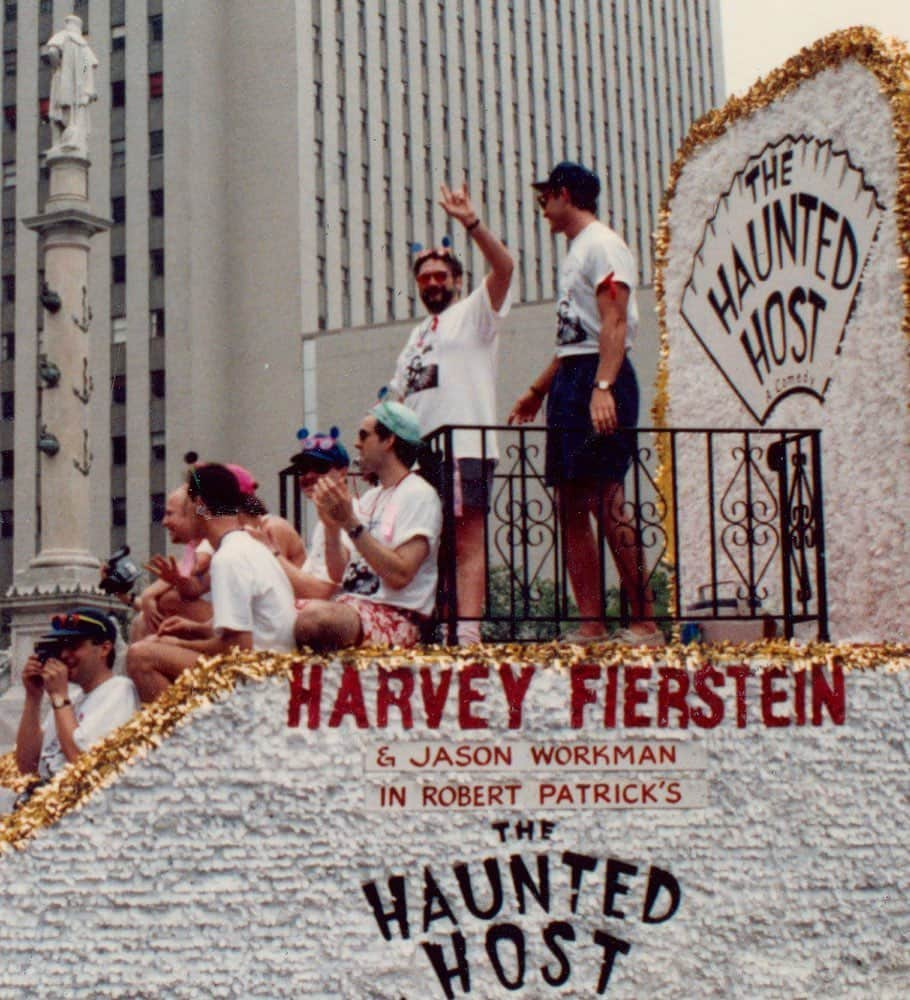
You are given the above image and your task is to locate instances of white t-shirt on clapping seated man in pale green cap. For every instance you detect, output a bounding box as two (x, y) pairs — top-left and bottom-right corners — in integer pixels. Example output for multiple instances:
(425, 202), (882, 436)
(341, 472), (442, 615)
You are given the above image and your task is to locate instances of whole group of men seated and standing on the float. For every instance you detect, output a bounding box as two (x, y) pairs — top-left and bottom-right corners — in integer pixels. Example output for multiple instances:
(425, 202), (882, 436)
(10, 156), (661, 778)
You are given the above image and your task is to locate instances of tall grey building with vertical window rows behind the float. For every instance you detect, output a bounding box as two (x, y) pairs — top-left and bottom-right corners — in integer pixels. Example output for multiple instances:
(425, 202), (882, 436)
(0, 0), (722, 588)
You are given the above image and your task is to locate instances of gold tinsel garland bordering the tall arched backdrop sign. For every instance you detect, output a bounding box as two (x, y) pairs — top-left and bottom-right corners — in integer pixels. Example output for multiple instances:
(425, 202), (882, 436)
(651, 27), (910, 568)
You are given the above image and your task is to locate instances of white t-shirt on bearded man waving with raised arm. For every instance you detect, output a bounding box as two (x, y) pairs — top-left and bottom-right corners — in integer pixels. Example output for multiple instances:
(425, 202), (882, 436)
(389, 281), (511, 458)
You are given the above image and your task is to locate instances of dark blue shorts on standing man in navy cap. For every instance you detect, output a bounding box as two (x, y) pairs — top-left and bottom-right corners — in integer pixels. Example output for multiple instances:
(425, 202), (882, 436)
(546, 354), (638, 486)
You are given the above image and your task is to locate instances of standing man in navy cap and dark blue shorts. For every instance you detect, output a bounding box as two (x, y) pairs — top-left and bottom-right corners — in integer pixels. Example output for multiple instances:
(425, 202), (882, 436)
(509, 162), (662, 645)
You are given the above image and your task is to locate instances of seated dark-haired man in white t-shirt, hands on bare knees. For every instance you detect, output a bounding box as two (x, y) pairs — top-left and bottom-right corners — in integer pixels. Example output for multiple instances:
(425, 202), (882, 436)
(127, 464), (295, 701)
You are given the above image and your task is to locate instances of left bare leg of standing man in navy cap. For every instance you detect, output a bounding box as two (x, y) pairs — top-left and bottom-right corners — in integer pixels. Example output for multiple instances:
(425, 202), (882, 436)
(558, 483), (606, 638)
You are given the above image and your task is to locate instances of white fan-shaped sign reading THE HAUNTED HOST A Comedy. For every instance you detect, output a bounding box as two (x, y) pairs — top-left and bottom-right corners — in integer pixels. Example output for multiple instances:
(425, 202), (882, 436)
(681, 136), (884, 424)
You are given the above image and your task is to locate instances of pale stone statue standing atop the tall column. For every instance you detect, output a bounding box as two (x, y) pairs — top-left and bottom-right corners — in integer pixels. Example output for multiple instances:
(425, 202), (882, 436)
(41, 14), (98, 157)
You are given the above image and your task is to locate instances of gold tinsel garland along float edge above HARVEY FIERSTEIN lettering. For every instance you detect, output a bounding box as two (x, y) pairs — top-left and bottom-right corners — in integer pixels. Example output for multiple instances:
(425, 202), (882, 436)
(0, 639), (910, 854)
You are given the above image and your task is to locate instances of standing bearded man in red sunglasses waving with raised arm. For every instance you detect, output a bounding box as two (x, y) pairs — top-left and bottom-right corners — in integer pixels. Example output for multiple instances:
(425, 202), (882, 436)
(389, 184), (514, 645)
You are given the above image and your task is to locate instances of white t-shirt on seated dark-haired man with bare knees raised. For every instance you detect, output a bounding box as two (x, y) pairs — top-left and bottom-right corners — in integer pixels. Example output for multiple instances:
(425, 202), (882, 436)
(211, 530), (296, 653)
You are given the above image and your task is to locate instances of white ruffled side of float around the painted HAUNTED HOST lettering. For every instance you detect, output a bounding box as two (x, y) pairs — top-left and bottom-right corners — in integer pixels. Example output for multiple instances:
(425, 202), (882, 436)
(0, 669), (910, 1000)
